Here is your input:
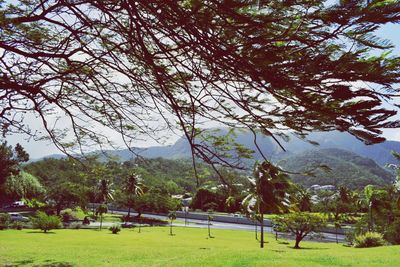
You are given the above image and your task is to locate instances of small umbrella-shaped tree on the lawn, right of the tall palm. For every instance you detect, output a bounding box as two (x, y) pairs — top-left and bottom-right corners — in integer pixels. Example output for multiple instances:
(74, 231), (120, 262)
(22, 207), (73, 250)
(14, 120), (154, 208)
(274, 212), (326, 248)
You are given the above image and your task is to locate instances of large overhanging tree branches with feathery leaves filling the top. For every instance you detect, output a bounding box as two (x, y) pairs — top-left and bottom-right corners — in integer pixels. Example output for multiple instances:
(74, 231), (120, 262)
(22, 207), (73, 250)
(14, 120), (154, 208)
(0, 0), (400, 171)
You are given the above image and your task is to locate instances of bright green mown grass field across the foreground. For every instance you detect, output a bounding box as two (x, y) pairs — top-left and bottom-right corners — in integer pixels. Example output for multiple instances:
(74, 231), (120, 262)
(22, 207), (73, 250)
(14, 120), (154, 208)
(0, 227), (400, 267)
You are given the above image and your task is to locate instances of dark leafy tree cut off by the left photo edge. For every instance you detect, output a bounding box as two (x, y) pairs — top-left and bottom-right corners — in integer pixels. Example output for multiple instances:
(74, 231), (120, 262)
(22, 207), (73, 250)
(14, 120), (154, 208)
(0, 142), (29, 186)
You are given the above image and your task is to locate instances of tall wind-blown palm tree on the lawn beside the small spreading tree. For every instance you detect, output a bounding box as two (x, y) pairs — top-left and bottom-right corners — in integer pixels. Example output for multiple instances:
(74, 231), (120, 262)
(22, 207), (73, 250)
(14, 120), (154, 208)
(243, 161), (291, 248)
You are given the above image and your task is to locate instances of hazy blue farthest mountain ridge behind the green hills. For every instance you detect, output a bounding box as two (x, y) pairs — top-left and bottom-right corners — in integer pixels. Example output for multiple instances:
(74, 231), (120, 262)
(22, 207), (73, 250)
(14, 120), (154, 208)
(36, 129), (400, 166)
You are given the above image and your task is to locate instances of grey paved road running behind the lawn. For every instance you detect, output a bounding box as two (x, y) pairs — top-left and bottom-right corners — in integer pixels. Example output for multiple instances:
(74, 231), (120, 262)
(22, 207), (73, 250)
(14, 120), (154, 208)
(113, 211), (345, 242)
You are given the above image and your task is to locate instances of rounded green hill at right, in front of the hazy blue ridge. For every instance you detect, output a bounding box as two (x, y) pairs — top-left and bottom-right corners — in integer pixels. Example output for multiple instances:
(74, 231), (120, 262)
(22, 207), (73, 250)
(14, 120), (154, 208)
(279, 149), (394, 189)
